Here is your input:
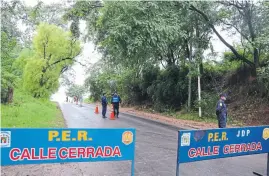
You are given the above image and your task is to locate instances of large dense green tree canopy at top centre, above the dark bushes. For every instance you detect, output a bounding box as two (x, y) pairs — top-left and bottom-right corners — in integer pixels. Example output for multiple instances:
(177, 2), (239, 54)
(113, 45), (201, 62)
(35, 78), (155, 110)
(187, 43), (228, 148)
(93, 2), (192, 66)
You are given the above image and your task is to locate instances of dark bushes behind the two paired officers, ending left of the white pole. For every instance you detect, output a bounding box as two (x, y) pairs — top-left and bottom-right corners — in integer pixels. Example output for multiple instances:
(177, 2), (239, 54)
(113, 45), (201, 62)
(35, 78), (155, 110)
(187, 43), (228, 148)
(87, 65), (191, 112)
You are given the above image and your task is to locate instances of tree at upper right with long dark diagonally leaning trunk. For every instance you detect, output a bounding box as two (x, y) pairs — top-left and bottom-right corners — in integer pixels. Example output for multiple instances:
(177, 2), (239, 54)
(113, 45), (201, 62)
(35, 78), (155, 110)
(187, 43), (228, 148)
(190, 1), (268, 67)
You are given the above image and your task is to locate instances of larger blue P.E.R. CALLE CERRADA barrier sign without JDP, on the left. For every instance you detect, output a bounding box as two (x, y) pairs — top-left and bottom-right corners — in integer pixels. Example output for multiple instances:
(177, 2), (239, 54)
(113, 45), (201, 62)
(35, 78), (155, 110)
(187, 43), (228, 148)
(0, 128), (136, 176)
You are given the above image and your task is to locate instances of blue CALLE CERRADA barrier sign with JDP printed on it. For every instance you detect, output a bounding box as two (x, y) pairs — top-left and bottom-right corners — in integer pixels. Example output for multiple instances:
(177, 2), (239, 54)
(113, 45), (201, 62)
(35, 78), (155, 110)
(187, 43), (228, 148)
(176, 126), (269, 176)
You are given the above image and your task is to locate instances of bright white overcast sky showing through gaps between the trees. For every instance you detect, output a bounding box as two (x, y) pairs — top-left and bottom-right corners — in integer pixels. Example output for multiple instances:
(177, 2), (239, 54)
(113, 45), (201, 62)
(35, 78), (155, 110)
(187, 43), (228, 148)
(22, 0), (239, 101)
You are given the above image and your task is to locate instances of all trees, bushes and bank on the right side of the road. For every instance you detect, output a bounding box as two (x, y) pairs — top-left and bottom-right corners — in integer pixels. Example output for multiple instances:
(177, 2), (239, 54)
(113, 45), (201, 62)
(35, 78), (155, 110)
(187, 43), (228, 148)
(64, 1), (269, 125)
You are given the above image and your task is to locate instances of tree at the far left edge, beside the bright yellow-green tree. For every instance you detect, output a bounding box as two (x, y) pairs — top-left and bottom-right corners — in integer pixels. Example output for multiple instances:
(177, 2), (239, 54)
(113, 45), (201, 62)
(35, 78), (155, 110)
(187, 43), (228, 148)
(1, 1), (24, 103)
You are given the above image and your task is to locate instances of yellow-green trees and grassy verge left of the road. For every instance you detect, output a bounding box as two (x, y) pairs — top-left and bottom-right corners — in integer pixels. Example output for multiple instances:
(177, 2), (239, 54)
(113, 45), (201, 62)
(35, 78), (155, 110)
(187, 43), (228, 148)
(1, 1), (81, 127)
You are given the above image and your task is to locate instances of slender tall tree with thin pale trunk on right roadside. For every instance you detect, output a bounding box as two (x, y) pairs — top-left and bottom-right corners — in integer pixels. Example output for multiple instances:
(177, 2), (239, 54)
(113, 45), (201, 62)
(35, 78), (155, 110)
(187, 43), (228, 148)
(175, 2), (212, 115)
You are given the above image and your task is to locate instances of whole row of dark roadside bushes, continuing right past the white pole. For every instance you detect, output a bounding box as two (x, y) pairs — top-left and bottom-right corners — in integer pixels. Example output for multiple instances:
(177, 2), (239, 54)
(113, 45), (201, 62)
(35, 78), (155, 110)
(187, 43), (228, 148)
(88, 62), (245, 117)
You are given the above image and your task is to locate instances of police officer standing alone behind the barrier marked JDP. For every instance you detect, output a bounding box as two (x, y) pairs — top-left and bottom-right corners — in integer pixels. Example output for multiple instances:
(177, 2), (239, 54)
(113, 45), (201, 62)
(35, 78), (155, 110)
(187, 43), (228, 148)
(216, 94), (227, 128)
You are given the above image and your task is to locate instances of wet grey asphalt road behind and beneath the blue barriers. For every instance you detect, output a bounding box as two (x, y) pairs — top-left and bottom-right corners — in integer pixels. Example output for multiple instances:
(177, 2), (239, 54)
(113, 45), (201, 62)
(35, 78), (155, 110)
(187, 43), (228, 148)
(1, 103), (267, 176)
